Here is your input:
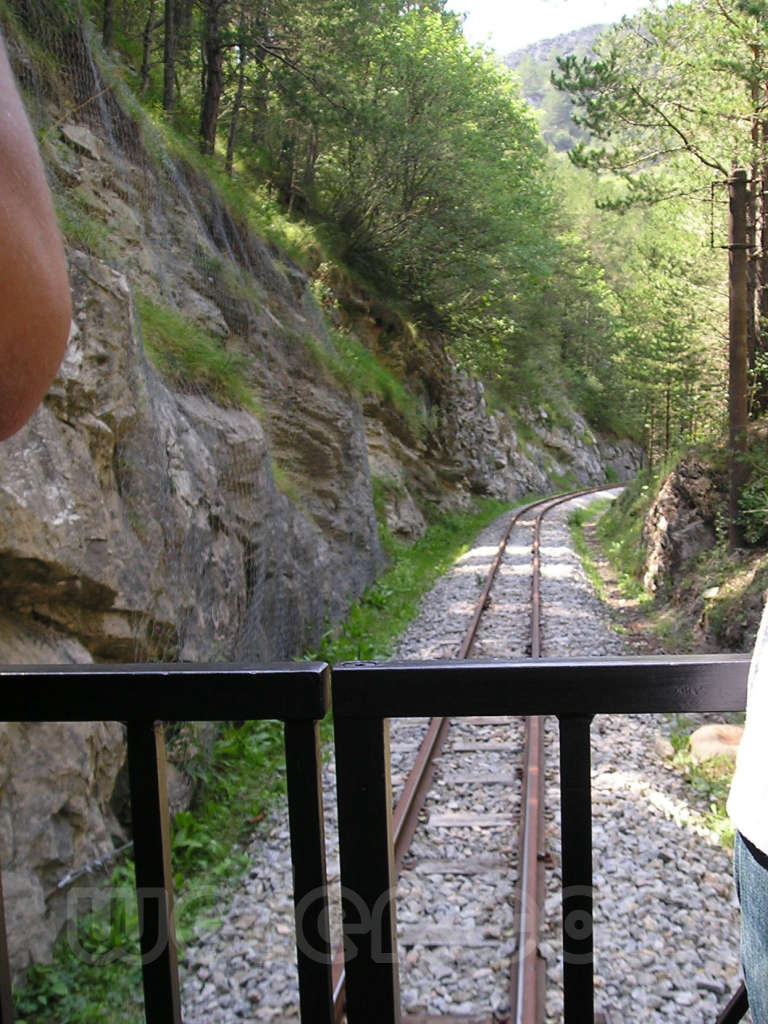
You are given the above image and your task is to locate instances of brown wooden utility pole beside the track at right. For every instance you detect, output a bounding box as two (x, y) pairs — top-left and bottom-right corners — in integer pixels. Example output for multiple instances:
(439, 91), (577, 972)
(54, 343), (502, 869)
(728, 168), (749, 550)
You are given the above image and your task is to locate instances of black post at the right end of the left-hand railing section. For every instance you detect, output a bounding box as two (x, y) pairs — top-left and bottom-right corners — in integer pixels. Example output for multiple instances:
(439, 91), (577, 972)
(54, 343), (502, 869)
(285, 720), (334, 1024)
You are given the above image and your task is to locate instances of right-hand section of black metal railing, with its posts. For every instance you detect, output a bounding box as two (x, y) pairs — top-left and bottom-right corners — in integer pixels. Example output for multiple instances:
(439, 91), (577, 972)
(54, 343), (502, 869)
(333, 655), (749, 1024)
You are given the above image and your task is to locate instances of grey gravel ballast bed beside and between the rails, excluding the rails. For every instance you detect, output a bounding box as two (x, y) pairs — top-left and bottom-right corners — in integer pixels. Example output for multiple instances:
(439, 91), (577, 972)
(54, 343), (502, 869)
(183, 487), (738, 1024)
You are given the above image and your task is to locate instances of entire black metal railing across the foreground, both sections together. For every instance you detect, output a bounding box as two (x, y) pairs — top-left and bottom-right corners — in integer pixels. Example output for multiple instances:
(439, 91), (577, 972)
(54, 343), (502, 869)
(0, 655), (749, 1024)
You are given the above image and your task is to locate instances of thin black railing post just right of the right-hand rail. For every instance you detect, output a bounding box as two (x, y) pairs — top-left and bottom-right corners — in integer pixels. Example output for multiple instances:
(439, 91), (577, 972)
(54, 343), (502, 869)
(558, 715), (595, 1024)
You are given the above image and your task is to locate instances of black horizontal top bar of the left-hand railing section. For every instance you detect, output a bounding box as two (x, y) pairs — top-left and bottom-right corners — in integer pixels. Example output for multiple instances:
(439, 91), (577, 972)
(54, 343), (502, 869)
(0, 662), (330, 722)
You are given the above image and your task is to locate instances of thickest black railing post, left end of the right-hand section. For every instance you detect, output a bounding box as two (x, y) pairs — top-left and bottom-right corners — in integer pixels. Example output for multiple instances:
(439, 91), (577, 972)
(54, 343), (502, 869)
(334, 717), (400, 1024)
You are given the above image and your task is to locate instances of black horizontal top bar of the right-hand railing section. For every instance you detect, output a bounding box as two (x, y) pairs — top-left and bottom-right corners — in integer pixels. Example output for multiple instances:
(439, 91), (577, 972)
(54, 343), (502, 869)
(333, 654), (750, 719)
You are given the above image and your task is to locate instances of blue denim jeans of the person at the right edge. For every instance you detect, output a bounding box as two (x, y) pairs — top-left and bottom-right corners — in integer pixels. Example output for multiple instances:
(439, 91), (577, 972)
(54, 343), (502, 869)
(733, 833), (768, 1024)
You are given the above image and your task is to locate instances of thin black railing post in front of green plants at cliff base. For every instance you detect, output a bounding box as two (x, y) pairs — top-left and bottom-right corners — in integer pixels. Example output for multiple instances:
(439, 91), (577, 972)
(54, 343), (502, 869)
(128, 721), (181, 1024)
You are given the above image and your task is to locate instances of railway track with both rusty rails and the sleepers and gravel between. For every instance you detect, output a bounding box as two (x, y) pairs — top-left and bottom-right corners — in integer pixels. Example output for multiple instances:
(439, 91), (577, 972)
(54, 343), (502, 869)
(335, 488), (622, 1024)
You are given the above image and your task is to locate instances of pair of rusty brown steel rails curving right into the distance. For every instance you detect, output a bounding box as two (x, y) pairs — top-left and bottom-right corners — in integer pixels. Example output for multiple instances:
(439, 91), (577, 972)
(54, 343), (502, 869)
(332, 484), (611, 1024)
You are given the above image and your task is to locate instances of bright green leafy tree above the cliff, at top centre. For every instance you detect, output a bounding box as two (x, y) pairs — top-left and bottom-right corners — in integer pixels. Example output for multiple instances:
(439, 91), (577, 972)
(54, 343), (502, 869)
(317, 10), (549, 313)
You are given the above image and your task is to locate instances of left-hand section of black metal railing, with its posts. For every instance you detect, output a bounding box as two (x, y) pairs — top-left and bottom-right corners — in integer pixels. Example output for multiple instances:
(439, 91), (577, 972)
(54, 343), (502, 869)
(0, 663), (333, 1024)
